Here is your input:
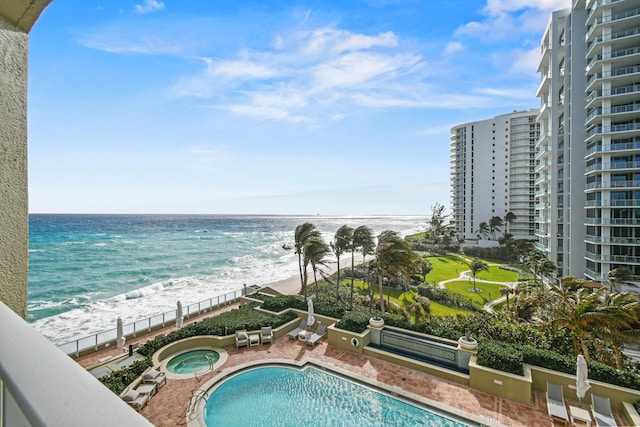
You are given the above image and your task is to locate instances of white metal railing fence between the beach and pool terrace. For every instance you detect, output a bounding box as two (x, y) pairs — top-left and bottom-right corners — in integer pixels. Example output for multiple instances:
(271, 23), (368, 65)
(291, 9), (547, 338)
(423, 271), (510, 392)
(58, 287), (256, 357)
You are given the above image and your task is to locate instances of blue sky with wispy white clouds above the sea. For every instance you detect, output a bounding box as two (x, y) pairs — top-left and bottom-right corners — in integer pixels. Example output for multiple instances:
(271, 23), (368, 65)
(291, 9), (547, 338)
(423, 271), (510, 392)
(28, 0), (570, 215)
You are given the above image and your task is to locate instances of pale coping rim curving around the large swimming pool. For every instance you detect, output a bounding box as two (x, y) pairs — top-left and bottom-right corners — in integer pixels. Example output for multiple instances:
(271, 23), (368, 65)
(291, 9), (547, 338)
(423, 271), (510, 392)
(186, 357), (506, 427)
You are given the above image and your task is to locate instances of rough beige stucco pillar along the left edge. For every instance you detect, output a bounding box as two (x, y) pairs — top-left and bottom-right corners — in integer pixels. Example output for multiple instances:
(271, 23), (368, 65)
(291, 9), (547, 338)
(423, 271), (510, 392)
(0, 17), (29, 318)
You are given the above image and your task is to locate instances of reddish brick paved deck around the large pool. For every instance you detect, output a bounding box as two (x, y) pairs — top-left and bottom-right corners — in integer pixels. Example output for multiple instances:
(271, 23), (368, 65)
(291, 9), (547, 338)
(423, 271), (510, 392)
(77, 304), (626, 427)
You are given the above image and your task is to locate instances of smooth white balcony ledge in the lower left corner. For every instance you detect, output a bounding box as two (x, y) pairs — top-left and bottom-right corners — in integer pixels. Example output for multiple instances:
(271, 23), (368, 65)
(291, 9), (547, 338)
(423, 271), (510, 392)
(0, 302), (151, 427)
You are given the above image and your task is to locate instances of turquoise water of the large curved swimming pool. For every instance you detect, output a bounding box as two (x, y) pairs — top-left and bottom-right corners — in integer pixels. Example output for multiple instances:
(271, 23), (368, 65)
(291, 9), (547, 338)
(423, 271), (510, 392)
(204, 367), (471, 427)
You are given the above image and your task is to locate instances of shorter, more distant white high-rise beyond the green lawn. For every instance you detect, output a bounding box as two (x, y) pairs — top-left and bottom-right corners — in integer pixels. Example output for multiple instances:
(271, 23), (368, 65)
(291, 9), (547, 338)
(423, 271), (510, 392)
(451, 110), (539, 245)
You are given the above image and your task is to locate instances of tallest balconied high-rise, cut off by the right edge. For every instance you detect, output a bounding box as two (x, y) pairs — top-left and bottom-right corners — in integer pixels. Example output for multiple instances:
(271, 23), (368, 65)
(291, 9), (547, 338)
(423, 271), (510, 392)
(536, 0), (640, 288)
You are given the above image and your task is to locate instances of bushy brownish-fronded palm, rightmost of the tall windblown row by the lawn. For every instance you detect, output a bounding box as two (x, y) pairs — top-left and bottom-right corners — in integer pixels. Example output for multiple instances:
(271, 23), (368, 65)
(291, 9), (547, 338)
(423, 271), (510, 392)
(375, 230), (417, 314)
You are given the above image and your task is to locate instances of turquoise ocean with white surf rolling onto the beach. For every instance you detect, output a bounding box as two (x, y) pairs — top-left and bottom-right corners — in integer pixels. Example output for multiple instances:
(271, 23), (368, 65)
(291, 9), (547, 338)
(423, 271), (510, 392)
(28, 214), (427, 345)
